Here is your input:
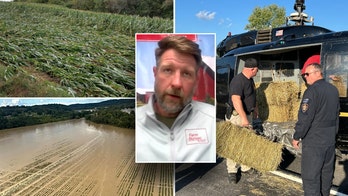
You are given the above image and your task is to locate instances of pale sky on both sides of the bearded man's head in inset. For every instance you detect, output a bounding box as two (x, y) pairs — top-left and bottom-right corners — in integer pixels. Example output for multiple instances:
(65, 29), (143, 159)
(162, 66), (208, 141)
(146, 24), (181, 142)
(135, 33), (216, 94)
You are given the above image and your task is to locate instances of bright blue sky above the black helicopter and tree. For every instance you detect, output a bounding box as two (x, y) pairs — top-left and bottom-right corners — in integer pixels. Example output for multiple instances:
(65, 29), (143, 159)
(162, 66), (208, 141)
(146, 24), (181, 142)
(174, 0), (348, 44)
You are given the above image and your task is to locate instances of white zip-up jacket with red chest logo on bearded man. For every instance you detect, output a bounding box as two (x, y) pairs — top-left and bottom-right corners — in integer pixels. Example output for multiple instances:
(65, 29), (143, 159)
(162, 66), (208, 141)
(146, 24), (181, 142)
(135, 96), (216, 163)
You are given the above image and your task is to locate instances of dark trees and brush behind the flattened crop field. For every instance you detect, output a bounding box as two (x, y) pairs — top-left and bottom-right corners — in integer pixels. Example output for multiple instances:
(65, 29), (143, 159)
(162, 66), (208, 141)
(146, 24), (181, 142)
(15, 0), (173, 19)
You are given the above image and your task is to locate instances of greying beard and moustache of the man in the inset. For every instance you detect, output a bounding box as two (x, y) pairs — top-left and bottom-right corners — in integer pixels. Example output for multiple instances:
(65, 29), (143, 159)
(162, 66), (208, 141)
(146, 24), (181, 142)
(155, 86), (193, 114)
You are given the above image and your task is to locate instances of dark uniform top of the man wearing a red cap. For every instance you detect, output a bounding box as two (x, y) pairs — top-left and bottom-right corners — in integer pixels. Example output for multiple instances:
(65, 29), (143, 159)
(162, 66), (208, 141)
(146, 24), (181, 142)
(294, 79), (340, 146)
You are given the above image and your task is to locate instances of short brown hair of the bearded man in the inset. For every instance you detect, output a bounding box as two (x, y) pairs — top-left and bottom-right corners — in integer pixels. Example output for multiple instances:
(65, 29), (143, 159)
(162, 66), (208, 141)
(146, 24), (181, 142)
(155, 35), (202, 70)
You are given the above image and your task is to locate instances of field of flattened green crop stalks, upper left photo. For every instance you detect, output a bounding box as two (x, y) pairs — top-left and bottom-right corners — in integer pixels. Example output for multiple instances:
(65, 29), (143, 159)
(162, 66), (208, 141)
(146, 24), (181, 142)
(0, 2), (173, 97)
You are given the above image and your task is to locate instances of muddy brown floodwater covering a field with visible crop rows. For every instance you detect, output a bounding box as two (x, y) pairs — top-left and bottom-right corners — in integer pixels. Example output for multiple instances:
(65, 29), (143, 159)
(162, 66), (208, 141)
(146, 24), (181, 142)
(0, 119), (174, 196)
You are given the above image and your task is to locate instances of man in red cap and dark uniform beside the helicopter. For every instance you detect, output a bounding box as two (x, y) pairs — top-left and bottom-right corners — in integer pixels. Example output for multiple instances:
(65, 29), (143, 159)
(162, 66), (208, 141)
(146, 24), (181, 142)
(292, 55), (340, 196)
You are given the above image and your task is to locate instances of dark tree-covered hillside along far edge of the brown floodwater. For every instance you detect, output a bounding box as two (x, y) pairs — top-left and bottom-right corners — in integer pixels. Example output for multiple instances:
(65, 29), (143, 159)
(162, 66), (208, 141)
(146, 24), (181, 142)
(0, 99), (135, 130)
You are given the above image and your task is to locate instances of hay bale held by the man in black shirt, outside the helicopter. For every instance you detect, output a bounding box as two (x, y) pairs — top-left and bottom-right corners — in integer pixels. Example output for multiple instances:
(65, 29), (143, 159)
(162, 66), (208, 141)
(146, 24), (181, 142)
(216, 121), (283, 172)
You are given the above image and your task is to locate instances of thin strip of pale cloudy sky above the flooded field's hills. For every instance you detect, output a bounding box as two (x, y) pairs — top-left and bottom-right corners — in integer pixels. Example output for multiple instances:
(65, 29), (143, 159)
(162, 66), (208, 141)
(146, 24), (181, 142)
(0, 97), (123, 107)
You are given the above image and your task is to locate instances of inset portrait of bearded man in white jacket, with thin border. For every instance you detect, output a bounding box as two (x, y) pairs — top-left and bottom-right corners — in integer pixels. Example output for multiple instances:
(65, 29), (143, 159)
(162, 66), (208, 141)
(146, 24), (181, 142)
(135, 33), (216, 163)
